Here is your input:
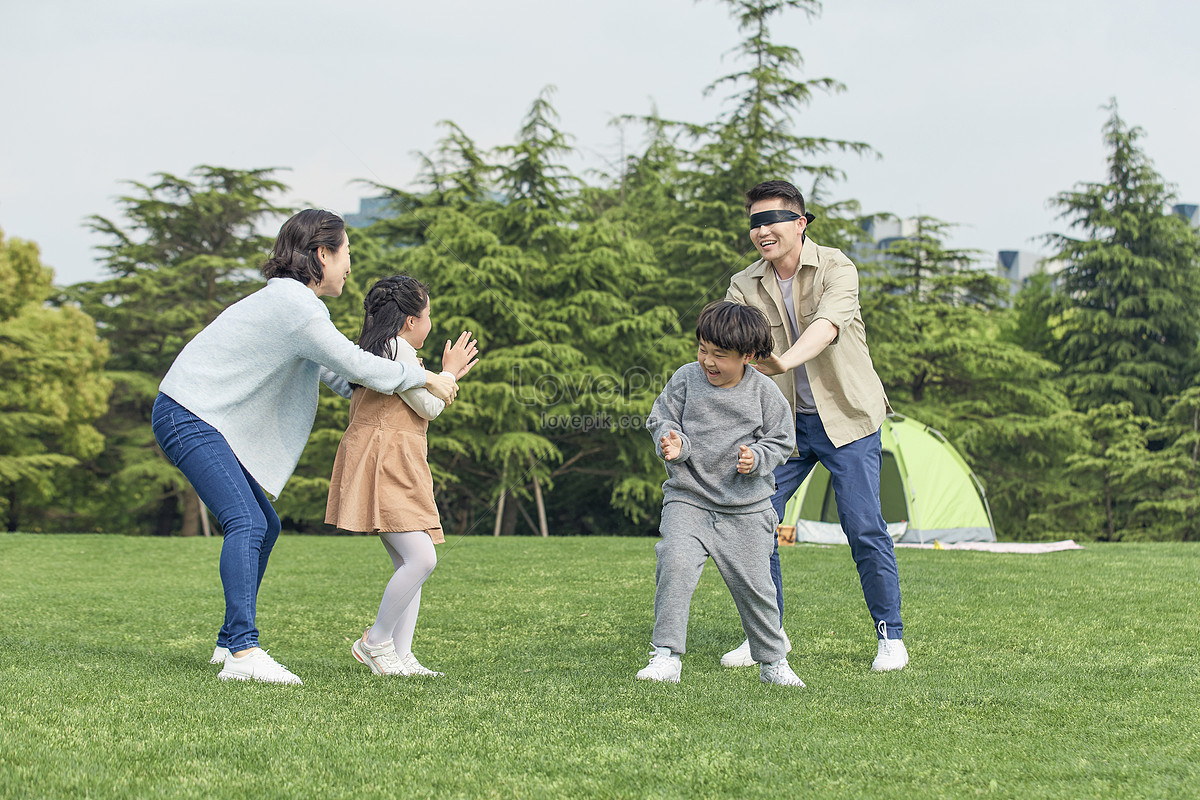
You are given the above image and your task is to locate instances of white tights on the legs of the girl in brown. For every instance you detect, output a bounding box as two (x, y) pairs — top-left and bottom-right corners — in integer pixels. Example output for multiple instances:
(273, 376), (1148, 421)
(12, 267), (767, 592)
(367, 530), (438, 657)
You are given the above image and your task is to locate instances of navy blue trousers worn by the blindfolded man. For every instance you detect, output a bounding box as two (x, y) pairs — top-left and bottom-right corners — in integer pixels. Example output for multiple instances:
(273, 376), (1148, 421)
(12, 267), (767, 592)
(770, 414), (904, 639)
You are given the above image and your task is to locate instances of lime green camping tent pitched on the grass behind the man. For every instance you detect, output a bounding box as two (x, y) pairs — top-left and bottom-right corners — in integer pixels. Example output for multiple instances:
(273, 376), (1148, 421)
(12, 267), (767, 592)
(781, 414), (996, 545)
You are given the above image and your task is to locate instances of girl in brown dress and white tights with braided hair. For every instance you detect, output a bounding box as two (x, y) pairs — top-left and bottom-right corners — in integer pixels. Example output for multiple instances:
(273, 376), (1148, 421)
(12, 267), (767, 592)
(325, 275), (479, 676)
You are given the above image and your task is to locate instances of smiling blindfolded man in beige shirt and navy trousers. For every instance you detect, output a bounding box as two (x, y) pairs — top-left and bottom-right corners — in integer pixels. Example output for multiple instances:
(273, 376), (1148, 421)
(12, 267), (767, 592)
(721, 181), (908, 672)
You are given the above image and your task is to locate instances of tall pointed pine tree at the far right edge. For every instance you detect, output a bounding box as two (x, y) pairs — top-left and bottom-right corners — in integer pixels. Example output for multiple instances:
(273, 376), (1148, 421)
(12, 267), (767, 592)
(1048, 101), (1200, 417)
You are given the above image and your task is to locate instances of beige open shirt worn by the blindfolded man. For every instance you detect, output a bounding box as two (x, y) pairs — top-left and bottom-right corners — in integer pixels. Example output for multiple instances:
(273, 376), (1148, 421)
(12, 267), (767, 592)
(726, 237), (892, 447)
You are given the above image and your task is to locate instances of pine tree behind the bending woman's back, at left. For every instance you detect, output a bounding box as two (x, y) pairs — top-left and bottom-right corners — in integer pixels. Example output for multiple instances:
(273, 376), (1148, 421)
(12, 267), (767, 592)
(65, 166), (287, 535)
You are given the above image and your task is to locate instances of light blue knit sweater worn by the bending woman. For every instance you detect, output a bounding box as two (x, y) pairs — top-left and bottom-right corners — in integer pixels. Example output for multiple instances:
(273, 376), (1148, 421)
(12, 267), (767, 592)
(158, 278), (425, 497)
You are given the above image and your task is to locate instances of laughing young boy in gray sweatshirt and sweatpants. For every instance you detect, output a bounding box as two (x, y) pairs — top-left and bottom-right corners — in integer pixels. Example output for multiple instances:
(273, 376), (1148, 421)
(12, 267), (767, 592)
(637, 300), (804, 687)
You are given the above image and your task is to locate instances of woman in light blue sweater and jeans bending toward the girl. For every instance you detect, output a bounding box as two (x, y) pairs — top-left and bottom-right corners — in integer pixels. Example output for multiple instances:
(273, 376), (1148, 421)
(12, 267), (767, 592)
(151, 209), (476, 684)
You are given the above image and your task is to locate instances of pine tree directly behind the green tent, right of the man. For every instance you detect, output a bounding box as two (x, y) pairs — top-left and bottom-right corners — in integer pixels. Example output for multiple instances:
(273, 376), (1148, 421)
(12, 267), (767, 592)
(863, 217), (1081, 539)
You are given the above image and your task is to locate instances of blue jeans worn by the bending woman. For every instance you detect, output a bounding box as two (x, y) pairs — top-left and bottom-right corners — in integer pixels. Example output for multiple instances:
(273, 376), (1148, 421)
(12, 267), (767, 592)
(150, 393), (280, 652)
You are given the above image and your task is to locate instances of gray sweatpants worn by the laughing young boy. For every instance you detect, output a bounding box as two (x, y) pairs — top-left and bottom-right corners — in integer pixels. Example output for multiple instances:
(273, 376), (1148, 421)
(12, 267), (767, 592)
(650, 501), (786, 662)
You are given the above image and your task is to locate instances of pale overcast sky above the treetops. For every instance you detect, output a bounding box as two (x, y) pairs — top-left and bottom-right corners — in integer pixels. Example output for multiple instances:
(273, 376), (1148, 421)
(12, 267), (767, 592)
(0, 0), (1200, 284)
